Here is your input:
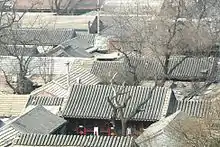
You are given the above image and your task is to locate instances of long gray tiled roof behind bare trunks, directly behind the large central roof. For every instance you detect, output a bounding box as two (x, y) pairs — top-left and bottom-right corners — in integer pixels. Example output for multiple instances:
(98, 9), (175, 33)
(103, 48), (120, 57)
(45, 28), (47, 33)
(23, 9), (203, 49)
(91, 56), (216, 83)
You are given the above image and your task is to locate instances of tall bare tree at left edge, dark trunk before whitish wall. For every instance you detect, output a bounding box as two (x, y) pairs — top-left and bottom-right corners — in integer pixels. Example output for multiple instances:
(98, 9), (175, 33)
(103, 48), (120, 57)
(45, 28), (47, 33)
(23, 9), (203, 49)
(0, 0), (51, 94)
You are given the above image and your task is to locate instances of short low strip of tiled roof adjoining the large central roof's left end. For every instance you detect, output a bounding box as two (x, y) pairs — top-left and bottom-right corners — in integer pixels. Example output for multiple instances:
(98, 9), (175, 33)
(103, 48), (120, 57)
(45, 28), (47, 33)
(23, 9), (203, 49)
(26, 96), (64, 107)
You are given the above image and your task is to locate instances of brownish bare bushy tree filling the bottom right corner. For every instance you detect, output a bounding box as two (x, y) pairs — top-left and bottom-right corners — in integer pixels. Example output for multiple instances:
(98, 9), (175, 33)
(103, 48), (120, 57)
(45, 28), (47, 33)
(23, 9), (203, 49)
(168, 99), (220, 147)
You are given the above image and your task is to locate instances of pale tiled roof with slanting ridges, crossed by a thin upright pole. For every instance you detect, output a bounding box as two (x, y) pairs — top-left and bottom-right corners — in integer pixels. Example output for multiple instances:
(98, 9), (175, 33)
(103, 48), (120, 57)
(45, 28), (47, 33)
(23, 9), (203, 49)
(31, 67), (100, 97)
